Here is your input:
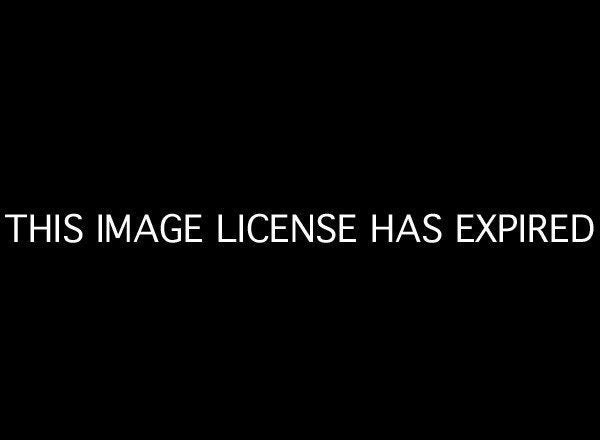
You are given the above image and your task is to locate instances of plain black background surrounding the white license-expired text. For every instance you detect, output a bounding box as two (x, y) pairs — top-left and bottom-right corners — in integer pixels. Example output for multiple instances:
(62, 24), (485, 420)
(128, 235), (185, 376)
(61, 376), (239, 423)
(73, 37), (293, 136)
(1, 5), (598, 433)
